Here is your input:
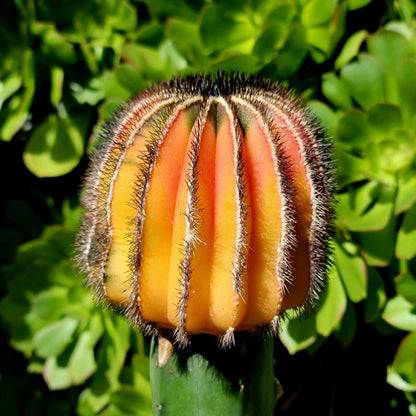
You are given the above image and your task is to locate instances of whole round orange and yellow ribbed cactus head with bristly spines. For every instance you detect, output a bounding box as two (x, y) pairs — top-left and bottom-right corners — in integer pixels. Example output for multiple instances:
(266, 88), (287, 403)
(78, 75), (332, 345)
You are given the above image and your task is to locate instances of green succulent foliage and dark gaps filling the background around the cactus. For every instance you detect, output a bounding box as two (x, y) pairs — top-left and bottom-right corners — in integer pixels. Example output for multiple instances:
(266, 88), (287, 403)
(0, 0), (416, 416)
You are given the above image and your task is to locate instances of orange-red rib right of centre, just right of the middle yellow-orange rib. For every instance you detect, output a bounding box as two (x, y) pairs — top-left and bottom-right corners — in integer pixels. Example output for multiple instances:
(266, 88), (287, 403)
(233, 98), (287, 327)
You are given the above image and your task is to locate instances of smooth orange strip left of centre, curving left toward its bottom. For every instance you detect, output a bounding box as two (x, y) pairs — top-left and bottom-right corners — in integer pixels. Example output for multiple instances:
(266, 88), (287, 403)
(137, 102), (201, 326)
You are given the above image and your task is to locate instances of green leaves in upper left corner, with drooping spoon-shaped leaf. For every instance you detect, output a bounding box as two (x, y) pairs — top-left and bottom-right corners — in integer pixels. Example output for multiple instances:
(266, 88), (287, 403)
(0, 0), (141, 177)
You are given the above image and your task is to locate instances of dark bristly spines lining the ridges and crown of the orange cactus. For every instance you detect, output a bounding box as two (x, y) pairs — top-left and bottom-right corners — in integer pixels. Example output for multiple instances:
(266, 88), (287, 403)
(76, 72), (335, 347)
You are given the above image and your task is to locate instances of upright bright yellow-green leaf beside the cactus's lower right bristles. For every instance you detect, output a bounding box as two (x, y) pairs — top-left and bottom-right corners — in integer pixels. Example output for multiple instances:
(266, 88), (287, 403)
(316, 267), (347, 337)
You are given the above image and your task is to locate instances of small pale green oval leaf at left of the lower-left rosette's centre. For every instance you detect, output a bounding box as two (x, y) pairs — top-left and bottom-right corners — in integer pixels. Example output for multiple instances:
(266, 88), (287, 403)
(35, 317), (78, 358)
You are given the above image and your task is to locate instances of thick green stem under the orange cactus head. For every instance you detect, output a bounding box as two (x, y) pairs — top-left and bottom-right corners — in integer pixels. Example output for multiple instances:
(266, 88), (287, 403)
(150, 335), (277, 416)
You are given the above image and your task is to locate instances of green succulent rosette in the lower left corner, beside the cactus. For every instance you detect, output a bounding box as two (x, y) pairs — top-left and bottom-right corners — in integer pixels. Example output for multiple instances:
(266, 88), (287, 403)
(0, 209), (151, 416)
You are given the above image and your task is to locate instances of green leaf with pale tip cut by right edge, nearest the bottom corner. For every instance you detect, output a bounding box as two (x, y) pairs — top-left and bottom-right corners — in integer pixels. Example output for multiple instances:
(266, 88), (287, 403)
(387, 333), (416, 392)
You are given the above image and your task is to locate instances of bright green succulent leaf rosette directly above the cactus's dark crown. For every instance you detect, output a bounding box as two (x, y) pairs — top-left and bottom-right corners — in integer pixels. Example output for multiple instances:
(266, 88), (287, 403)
(162, 0), (371, 75)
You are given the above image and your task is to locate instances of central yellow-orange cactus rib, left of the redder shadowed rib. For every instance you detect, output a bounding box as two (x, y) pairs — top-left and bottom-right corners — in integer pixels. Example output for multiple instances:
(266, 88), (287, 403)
(209, 99), (247, 331)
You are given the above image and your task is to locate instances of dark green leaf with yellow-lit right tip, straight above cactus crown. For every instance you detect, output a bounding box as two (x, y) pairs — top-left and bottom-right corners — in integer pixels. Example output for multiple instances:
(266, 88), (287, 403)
(200, 5), (256, 51)
